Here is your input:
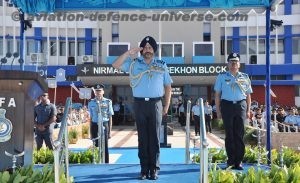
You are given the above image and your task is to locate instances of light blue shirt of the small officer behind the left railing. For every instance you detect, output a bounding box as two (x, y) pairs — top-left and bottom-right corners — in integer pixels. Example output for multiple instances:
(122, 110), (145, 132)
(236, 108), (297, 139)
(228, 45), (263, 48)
(88, 97), (114, 123)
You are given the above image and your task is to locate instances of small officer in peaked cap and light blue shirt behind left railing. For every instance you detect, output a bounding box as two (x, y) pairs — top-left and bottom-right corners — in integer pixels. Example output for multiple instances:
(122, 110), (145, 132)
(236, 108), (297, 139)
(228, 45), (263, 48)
(88, 84), (114, 163)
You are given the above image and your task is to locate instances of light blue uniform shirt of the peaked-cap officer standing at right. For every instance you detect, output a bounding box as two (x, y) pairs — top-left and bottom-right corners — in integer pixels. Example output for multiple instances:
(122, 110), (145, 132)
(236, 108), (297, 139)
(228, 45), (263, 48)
(214, 72), (253, 101)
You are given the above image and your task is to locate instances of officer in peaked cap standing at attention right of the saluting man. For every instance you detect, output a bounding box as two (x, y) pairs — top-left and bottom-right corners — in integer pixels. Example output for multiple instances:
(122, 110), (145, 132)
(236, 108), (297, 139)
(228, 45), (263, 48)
(214, 53), (252, 170)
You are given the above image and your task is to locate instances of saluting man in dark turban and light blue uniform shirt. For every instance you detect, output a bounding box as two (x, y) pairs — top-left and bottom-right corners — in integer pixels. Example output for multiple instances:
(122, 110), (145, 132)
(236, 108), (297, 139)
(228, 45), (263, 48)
(113, 36), (173, 180)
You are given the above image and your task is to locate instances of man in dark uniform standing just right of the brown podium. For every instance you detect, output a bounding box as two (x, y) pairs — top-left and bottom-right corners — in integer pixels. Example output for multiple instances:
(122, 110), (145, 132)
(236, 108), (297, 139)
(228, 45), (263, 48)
(34, 92), (57, 150)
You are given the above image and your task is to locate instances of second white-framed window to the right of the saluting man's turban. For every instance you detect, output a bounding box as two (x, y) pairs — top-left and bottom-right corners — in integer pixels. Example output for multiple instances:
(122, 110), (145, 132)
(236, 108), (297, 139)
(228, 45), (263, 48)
(193, 42), (214, 56)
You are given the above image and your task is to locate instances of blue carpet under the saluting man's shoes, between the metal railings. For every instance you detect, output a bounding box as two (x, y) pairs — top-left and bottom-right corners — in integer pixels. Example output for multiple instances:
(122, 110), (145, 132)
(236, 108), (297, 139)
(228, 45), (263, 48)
(70, 164), (199, 183)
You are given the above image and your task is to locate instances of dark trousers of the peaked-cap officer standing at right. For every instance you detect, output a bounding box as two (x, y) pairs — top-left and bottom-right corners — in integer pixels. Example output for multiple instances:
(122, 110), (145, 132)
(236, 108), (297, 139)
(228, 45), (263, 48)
(221, 100), (247, 166)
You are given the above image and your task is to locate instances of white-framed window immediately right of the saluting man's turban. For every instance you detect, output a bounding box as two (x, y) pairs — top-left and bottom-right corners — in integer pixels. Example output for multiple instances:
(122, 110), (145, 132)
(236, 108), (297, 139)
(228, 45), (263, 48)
(155, 42), (183, 57)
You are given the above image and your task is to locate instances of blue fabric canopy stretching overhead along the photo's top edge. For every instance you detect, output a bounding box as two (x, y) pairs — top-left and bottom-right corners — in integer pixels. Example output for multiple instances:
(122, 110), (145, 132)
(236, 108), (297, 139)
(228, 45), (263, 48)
(11, 0), (270, 14)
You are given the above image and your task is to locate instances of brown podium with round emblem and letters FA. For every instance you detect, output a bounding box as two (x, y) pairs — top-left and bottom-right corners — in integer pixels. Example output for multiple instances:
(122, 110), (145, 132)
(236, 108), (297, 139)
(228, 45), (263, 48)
(0, 70), (47, 171)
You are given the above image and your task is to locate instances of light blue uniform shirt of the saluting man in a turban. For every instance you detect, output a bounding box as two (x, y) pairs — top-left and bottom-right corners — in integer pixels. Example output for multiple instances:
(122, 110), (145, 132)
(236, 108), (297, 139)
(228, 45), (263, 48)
(121, 58), (173, 98)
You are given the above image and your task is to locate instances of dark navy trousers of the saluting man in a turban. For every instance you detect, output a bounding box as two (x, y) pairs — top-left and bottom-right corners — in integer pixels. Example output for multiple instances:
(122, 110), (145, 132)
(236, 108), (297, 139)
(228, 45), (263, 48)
(134, 99), (163, 174)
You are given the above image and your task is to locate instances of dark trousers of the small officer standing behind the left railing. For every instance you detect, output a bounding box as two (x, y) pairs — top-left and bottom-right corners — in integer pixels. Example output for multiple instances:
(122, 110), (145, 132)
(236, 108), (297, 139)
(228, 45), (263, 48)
(91, 122), (109, 163)
